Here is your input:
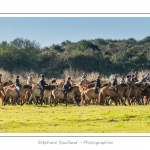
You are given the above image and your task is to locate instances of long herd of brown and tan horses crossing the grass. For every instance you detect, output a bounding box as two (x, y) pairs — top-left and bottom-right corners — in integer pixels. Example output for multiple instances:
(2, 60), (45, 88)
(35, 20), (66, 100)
(0, 80), (150, 106)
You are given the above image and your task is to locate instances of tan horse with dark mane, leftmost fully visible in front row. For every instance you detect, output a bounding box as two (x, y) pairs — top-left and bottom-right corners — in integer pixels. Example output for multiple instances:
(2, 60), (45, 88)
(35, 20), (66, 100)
(3, 85), (32, 106)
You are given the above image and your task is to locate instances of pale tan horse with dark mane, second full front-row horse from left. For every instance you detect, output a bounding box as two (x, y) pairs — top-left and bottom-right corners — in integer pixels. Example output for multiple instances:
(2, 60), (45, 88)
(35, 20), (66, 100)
(29, 84), (58, 105)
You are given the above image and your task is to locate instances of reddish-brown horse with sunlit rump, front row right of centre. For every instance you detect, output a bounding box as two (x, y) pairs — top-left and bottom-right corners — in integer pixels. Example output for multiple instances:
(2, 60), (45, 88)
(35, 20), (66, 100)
(98, 84), (131, 106)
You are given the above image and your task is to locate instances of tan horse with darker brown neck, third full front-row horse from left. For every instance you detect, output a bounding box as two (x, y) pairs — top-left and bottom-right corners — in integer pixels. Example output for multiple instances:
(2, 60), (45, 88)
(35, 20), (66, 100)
(52, 86), (80, 106)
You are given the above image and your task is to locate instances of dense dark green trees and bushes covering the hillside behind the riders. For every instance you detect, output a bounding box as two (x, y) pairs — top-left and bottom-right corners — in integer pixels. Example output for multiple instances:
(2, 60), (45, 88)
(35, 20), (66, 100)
(0, 36), (150, 77)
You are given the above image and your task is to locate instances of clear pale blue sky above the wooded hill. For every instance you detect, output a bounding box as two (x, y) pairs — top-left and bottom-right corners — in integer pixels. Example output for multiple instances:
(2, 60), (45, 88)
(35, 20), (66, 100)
(0, 17), (150, 47)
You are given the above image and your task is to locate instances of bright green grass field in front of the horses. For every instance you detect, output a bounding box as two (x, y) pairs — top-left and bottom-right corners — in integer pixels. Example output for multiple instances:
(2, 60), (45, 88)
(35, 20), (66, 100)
(0, 105), (150, 133)
